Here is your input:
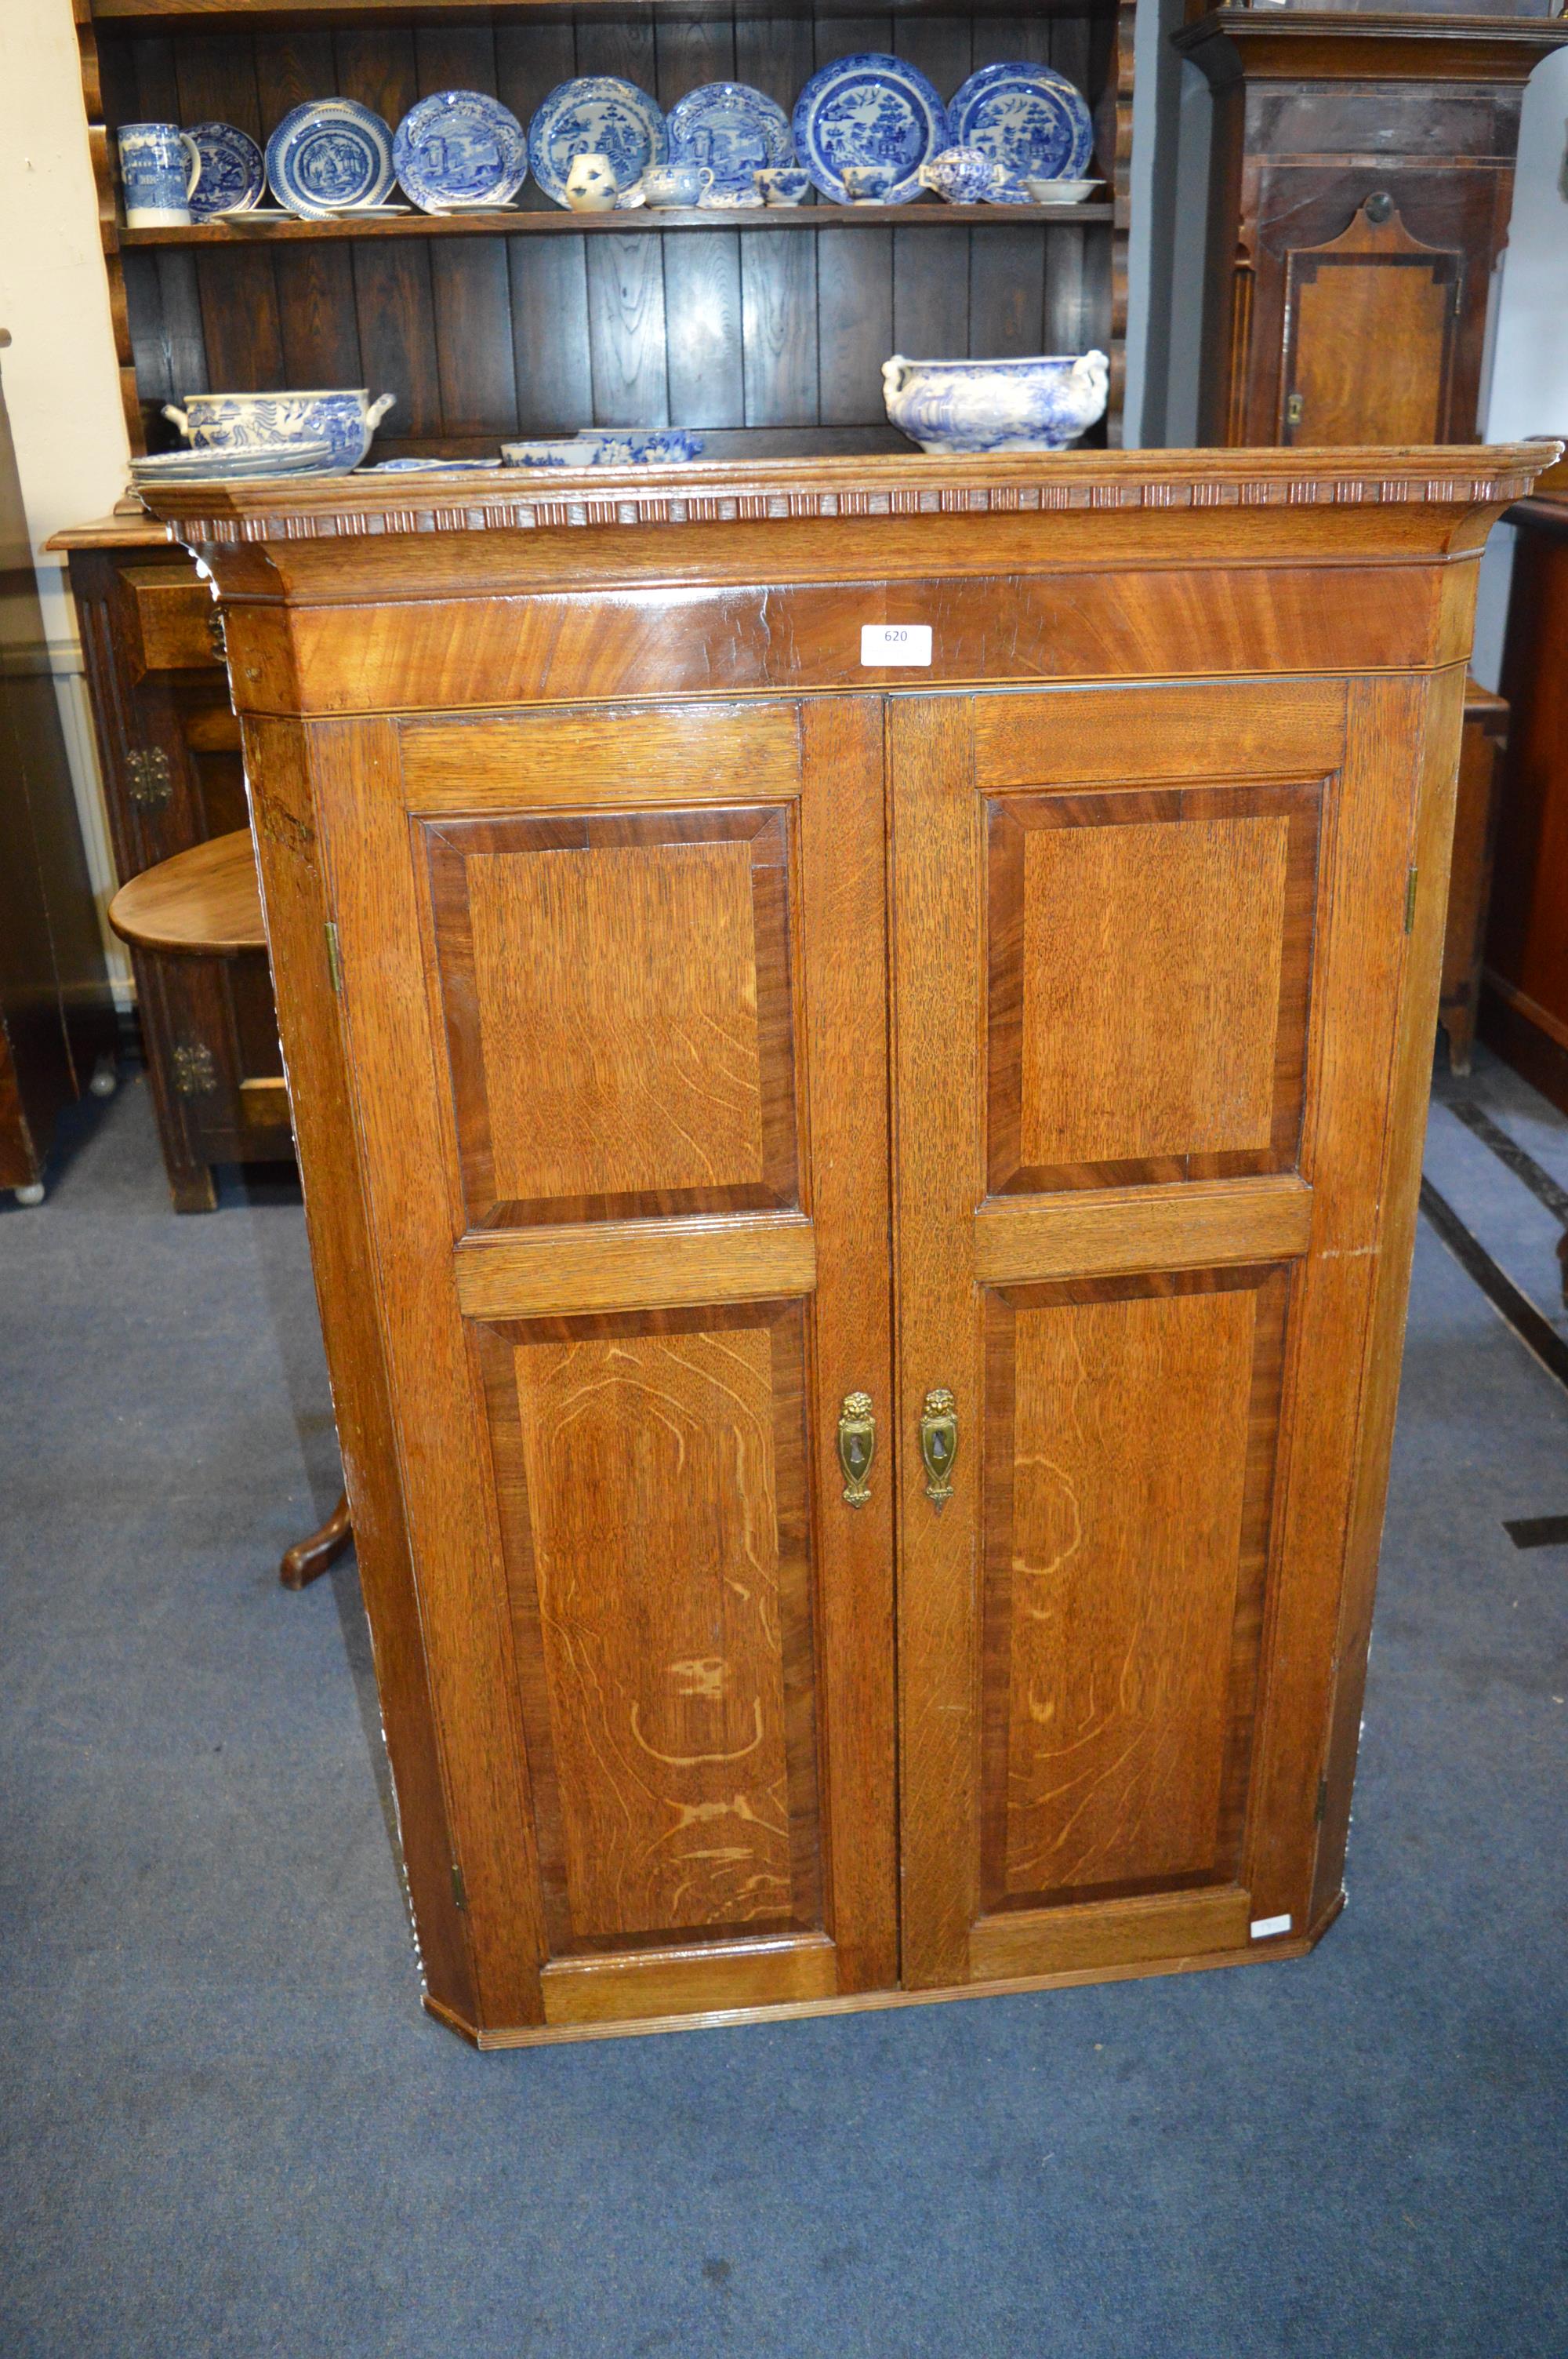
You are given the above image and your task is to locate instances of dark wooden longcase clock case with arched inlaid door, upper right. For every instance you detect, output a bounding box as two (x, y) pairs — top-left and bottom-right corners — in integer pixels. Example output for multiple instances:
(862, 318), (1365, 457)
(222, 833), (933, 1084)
(1177, 5), (1568, 449)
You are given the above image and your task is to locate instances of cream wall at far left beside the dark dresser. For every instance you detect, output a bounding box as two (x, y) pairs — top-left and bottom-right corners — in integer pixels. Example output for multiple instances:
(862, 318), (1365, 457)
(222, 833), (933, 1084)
(0, 0), (129, 995)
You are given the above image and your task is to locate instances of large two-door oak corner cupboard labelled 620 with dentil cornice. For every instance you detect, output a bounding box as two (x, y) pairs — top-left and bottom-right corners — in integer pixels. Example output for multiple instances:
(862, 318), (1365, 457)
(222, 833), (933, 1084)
(143, 449), (1549, 2045)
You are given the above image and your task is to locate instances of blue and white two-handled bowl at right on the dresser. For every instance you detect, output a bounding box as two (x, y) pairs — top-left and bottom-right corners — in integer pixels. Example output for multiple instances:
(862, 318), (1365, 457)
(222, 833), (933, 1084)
(882, 351), (1111, 456)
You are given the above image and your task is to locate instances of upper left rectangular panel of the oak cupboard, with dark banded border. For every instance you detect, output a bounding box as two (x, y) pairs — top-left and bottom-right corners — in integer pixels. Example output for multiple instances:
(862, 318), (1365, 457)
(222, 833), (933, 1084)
(422, 807), (797, 1227)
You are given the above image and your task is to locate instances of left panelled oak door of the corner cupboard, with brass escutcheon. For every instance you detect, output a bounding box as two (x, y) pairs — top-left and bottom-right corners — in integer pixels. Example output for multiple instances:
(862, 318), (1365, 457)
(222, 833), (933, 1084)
(314, 698), (896, 2029)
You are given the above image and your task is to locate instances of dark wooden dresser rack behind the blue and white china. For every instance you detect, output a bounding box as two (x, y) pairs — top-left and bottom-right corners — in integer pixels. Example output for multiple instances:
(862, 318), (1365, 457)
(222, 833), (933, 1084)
(75, 0), (1134, 458)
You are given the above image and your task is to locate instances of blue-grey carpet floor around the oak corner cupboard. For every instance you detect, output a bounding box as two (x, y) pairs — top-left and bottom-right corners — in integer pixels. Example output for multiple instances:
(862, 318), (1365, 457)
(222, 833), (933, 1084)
(0, 1067), (1568, 2359)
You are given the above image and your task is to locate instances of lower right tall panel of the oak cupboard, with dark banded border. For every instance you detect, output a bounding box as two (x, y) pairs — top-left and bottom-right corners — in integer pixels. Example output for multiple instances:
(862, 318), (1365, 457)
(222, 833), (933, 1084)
(981, 1269), (1287, 1910)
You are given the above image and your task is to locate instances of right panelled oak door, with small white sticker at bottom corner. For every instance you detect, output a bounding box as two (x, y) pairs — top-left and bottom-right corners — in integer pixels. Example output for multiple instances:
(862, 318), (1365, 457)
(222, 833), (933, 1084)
(889, 679), (1427, 1989)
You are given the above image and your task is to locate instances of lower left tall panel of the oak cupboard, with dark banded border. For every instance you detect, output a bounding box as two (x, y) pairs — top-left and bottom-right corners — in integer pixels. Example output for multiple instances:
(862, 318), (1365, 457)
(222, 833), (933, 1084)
(477, 1304), (821, 1956)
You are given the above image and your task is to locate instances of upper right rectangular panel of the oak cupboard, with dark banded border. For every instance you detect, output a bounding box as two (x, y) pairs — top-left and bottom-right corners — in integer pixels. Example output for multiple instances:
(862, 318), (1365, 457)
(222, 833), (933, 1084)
(988, 786), (1320, 1194)
